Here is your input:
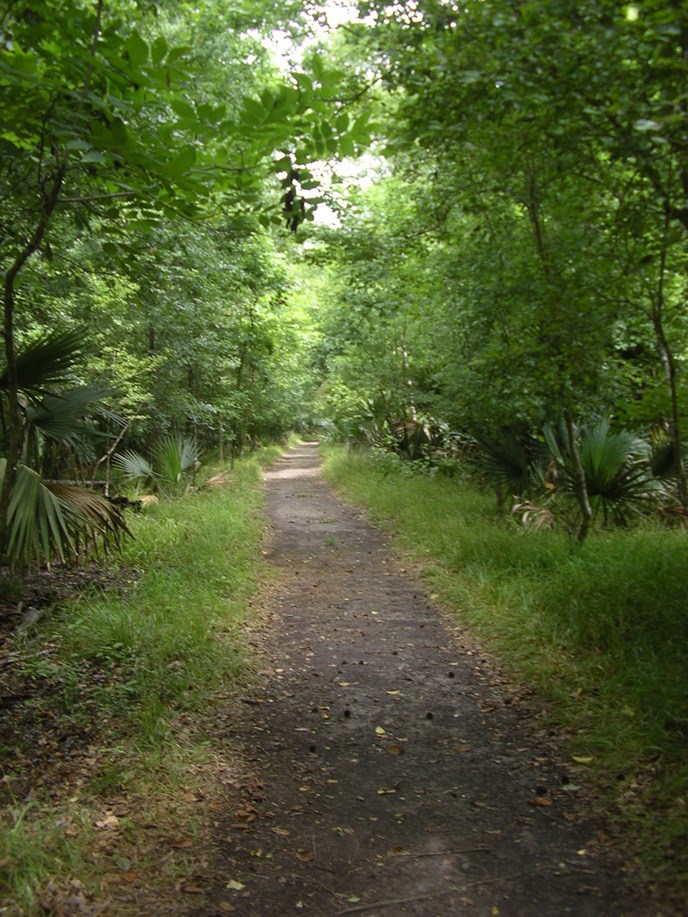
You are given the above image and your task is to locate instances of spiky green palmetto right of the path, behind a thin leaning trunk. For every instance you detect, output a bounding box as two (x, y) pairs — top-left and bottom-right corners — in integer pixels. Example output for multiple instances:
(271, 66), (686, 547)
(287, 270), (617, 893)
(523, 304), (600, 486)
(545, 419), (660, 524)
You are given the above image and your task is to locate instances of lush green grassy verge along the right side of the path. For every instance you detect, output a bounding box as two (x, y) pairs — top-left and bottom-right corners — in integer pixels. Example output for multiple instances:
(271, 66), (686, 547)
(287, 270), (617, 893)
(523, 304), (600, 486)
(325, 450), (688, 898)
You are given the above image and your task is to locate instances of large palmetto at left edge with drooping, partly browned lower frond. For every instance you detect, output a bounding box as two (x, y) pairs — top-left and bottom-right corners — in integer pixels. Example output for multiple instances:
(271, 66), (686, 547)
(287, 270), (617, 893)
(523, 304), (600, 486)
(0, 331), (128, 566)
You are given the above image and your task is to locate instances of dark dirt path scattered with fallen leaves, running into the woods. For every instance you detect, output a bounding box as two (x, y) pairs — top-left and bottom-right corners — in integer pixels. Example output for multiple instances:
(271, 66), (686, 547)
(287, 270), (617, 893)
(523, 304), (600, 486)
(203, 444), (659, 917)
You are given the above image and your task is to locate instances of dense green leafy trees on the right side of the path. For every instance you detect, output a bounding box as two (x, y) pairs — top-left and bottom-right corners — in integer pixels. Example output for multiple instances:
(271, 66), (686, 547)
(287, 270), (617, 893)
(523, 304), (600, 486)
(310, 0), (688, 537)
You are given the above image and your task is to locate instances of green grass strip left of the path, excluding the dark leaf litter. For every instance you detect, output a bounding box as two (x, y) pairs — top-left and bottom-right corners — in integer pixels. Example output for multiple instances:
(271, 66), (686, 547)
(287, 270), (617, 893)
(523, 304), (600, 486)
(0, 449), (279, 914)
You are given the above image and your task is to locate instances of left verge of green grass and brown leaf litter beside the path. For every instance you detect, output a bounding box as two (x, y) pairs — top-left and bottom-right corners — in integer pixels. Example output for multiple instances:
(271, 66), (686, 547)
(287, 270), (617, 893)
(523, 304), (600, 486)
(0, 449), (279, 914)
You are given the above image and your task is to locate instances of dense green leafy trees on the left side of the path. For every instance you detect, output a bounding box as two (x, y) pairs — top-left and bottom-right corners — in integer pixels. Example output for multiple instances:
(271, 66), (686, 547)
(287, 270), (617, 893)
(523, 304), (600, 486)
(0, 0), (367, 559)
